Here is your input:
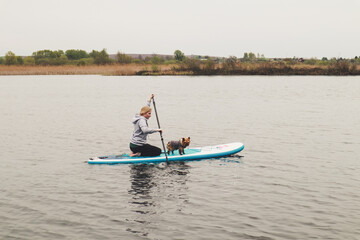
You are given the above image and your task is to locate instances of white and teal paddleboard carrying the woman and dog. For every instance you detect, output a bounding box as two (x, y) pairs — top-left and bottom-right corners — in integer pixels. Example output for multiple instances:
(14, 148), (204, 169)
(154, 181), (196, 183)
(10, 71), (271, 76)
(87, 142), (244, 164)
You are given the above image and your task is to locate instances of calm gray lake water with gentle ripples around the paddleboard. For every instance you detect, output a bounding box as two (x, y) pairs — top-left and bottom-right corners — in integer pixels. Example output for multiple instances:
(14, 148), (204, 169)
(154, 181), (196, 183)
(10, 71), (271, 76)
(0, 76), (360, 240)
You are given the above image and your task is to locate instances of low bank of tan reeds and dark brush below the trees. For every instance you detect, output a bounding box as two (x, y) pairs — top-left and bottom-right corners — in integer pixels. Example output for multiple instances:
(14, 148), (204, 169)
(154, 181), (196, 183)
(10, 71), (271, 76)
(0, 62), (360, 76)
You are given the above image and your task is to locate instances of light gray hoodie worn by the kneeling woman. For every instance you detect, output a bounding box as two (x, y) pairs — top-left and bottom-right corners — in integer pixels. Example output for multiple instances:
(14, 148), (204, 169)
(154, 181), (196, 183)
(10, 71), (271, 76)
(130, 101), (157, 146)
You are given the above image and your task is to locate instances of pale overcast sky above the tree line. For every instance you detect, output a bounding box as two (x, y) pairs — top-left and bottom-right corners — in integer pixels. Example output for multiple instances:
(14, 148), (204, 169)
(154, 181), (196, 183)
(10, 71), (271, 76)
(0, 0), (360, 58)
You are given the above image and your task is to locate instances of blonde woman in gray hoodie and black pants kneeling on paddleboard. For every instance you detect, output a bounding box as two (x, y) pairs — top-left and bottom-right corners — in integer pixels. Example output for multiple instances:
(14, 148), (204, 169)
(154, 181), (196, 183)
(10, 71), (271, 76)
(130, 94), (162, 157)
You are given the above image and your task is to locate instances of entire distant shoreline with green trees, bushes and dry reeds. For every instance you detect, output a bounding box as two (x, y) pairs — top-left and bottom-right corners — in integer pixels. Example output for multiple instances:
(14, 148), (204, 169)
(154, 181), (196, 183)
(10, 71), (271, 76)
(0, 49), (360, 76)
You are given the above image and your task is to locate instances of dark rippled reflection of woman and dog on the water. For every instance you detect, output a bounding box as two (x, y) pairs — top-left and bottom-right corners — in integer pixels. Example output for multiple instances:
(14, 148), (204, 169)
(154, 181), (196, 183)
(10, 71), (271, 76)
(127, 162), (191, 236)
